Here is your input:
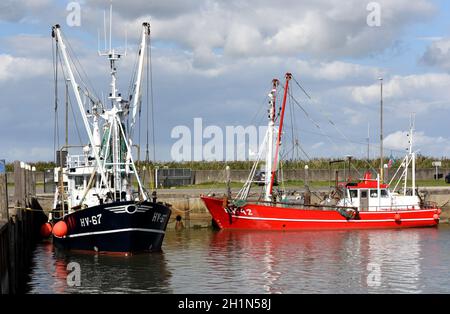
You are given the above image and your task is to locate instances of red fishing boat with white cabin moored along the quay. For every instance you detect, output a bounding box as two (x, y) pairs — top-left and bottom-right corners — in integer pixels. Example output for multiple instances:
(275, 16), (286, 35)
(201, 73), (441, 230)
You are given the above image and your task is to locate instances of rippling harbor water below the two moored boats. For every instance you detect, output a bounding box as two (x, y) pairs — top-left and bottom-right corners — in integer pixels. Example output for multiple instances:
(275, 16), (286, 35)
(28, 224), (450, 294)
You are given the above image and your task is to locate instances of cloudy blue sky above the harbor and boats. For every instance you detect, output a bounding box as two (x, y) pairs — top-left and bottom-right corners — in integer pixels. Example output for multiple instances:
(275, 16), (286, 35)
(0, 0), (450, 161)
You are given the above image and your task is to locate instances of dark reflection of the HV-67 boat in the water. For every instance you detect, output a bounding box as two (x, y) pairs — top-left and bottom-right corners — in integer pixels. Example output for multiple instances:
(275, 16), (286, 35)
(29, 242), (172, 293)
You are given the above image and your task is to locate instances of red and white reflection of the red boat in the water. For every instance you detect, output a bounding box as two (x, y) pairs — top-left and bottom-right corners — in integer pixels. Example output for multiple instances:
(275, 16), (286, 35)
(210, 229), (444, 293)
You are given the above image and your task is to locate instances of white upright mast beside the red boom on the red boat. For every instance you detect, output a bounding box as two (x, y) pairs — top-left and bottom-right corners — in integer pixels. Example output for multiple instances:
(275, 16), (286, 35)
(264, 79), (279, 201)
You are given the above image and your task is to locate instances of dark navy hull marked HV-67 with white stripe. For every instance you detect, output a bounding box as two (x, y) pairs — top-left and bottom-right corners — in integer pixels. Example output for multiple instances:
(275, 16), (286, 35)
(53, 202), (171, 253)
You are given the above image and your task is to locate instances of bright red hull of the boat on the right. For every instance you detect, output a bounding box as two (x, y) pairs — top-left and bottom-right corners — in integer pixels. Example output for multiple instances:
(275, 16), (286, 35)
(201, 196), (440, 230)
